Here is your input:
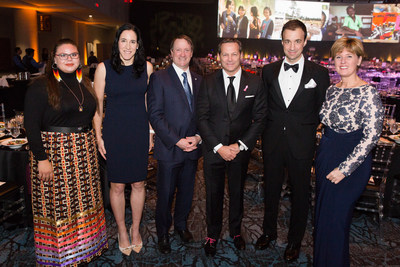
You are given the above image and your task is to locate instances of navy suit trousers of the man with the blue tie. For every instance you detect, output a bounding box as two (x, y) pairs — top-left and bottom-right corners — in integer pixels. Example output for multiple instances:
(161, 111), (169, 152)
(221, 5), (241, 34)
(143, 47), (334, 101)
(156, 159), (197, 238)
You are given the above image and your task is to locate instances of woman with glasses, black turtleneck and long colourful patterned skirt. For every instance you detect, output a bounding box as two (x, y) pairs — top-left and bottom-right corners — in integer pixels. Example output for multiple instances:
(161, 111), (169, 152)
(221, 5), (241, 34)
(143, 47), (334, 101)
(25, 39), (108, 266)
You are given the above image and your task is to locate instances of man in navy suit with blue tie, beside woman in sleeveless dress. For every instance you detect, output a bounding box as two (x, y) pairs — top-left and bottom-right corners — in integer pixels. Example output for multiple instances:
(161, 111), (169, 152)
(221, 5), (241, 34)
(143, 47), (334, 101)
(147, 35), (202, 254)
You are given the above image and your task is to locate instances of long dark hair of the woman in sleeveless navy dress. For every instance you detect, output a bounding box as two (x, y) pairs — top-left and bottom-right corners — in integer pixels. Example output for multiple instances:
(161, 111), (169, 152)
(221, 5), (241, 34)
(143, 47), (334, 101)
(111, 23), (146, 78)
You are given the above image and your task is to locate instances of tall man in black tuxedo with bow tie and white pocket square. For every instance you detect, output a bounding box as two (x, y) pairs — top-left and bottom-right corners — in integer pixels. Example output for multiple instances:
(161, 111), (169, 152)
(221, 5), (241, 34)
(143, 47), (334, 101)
(256, 20), (329, 261)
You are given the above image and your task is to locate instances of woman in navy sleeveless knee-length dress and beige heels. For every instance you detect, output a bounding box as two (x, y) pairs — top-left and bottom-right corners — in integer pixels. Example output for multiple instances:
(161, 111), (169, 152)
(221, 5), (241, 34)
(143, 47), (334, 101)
(94, 24), (153, 255)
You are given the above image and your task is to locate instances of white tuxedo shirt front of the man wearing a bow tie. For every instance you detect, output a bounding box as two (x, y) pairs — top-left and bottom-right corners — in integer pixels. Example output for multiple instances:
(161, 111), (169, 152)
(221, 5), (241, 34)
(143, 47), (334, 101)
(278, 56), (304, 107)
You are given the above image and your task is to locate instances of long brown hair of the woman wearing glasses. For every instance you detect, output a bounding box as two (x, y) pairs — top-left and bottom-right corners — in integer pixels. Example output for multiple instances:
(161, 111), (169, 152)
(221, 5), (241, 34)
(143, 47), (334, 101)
(46, 38), (97, 109)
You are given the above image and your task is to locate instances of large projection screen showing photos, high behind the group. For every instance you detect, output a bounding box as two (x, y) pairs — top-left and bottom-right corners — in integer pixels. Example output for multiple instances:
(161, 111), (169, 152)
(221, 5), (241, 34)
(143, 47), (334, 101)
(217, 0), (400, 43)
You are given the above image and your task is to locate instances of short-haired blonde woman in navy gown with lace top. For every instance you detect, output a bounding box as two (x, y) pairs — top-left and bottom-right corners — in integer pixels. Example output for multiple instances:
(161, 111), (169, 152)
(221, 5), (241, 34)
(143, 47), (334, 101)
(314, 37), (383, 267)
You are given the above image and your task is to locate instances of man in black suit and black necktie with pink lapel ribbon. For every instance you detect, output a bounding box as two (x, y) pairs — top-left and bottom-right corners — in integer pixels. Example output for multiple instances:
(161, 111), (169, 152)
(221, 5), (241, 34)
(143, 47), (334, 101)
(197, 39), (267, 256)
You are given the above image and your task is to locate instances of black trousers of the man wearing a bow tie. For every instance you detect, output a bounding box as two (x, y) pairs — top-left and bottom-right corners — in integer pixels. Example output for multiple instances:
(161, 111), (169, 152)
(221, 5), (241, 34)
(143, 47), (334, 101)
(263, 133), (312, 244)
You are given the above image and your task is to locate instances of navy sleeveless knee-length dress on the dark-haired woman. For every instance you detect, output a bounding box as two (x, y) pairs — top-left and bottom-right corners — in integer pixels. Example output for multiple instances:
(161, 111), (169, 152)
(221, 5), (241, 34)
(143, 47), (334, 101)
(103, 60), (149, 183)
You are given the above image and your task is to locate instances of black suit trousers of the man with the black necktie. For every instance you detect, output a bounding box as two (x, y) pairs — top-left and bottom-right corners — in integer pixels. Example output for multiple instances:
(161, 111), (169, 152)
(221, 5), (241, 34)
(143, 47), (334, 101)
(204, 151), (250, 239)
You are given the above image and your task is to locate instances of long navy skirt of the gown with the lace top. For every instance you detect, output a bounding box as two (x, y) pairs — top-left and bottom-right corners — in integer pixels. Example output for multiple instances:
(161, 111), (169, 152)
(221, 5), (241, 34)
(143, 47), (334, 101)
(314, 128), (372, 267)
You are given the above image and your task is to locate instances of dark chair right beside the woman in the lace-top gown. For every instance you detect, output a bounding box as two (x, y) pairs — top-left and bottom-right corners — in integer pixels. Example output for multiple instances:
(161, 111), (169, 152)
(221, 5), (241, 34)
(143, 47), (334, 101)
(355, 142), (396, 236)
